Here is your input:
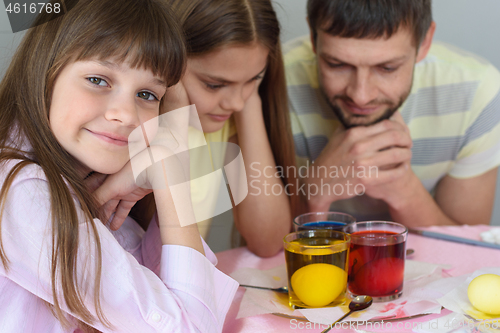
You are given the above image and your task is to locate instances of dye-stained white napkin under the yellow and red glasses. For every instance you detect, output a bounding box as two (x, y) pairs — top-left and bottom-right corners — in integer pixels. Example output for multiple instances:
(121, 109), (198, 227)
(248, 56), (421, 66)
(231, 260), (449, 325)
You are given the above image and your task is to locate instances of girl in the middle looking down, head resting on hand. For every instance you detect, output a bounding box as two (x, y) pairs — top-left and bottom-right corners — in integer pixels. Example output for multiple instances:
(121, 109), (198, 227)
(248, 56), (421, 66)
(165, 0), (300, 256)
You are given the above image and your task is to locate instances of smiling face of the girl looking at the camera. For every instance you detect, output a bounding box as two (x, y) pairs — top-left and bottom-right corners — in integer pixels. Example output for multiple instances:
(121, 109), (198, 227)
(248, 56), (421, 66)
(49, 60), (166, 174)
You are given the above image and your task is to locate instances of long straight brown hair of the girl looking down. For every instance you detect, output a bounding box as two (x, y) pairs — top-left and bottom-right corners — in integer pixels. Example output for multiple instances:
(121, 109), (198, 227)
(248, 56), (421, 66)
(167, 0), (304, 220)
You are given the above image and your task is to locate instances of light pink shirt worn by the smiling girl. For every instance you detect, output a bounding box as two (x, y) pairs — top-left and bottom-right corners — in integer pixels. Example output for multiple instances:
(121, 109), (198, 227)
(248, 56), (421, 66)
(0, 161), (238, 333)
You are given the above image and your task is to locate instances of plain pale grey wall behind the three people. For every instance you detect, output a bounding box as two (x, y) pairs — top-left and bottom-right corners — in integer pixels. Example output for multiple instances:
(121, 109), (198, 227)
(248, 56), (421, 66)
(0, 0), (500, 225)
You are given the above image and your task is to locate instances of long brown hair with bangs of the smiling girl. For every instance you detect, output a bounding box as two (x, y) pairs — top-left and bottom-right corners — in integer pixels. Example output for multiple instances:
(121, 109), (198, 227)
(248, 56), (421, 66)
(0, 0), (186, 327)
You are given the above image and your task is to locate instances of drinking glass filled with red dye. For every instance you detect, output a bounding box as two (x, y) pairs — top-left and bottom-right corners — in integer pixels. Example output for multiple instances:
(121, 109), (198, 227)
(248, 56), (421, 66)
(344, 221), (408, 302)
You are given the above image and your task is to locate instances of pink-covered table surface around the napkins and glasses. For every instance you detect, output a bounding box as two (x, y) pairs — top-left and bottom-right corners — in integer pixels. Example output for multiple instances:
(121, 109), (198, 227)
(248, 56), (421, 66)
(216, 225), (500, 333)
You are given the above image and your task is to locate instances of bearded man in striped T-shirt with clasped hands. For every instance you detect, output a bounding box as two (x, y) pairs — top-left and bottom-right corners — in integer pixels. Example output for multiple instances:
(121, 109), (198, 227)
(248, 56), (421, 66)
(284, 0), (500, 227)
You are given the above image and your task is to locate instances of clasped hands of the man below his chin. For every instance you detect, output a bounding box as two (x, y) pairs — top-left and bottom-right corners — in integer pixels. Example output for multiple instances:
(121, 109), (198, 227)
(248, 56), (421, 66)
(306, 113), (414, 211)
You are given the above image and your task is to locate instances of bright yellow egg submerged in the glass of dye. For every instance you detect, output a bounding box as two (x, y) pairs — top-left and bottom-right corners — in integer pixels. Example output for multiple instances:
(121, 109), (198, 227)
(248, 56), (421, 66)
(290, 264), (347, 307)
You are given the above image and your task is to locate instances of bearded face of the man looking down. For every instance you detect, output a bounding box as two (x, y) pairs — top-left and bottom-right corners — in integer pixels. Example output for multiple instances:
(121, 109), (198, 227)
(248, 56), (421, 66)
(315, 28), (417, 128)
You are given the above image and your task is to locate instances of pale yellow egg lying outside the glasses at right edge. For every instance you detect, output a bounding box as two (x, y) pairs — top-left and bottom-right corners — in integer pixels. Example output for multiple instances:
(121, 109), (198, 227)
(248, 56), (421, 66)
(467, 274), (500, 315)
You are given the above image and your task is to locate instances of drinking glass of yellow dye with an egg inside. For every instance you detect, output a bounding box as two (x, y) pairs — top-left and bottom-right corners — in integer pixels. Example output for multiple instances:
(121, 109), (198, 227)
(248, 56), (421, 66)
(283, 229), (351, 308)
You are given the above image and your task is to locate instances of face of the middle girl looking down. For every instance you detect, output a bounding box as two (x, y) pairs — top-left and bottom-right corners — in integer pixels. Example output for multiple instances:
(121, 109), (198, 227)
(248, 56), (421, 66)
(182, 43), (269, 133)
